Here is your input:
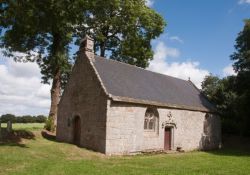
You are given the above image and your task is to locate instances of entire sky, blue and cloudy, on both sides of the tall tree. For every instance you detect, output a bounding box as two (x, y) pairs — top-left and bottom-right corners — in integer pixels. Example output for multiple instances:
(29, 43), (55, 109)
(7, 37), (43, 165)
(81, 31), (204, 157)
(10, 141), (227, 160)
(0, 0), (250, 115)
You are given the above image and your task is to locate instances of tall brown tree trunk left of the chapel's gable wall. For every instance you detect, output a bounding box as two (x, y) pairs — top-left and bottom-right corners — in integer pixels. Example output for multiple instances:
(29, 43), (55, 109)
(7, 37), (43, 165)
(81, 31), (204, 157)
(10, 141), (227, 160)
(49, 68), (61, 130)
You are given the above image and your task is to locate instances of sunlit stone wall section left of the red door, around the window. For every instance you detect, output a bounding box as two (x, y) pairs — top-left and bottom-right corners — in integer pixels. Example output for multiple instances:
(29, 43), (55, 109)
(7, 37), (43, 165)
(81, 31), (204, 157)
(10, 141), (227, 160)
(106, 101), (166, 154)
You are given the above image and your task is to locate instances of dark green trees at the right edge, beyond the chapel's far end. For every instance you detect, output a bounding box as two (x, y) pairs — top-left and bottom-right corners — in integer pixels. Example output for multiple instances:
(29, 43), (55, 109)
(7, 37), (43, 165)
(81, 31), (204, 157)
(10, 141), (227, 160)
(202, 19), (250, 136)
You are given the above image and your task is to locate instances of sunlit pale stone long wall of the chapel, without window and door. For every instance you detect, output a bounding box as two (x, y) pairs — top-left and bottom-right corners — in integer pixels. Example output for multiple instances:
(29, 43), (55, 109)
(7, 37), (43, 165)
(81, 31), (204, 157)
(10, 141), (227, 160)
(106, 101), (221, 154)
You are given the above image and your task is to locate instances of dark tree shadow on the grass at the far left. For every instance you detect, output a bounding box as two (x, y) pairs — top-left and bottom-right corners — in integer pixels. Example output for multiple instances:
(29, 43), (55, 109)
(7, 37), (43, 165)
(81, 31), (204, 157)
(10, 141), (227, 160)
(0, 128), (35, 148)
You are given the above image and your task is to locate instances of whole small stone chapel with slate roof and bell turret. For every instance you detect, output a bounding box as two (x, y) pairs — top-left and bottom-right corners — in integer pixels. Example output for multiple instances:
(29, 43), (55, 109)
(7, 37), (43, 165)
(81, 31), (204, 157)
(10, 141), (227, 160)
(56, 37), (221, 155)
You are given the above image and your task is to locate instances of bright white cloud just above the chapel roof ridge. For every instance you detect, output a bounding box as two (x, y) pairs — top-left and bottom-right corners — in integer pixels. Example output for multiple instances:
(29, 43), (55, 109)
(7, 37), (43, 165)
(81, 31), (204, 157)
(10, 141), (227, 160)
(148, 41), (209, 88)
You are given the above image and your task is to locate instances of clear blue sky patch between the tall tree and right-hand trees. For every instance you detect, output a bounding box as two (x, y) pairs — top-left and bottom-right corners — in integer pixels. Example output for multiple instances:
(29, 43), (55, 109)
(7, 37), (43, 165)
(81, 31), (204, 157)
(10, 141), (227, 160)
(148, 0), (250, 76)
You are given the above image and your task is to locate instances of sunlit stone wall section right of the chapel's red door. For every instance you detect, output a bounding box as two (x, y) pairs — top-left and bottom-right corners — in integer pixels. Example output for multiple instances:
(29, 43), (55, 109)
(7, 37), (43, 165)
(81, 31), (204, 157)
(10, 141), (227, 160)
(159, 109), (221, 151)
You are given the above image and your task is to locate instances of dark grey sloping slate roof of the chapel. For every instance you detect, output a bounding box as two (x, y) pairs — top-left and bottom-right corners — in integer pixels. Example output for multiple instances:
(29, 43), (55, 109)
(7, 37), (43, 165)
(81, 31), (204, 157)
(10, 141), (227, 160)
(93, 56), (215, 112)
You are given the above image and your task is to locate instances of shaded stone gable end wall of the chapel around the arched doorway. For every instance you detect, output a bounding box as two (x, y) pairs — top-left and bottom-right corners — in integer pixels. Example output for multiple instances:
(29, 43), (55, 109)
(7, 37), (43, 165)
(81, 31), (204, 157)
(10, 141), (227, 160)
(57, 55), (107, 153)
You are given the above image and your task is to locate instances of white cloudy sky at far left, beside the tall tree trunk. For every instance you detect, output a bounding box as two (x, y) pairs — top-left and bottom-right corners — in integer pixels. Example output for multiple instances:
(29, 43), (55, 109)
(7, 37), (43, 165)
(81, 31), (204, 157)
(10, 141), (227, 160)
(0, 58), (50, 115)
